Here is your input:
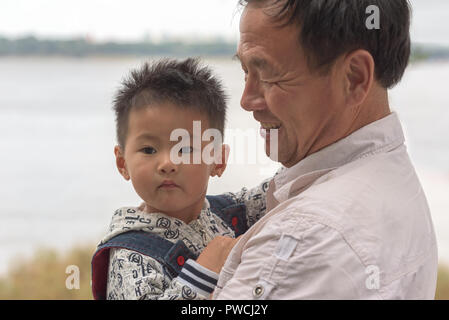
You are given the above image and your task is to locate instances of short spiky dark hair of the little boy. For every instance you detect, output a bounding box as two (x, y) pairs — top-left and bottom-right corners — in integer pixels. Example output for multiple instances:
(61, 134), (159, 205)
(113, 58), (227, 149)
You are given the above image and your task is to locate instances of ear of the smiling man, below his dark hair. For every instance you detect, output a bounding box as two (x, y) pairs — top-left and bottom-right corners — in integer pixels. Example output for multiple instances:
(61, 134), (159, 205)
(344, 49), (375, 106)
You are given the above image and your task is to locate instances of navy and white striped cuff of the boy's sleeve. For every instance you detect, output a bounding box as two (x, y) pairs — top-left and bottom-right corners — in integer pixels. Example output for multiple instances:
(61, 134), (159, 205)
(176, 259), (218, 297)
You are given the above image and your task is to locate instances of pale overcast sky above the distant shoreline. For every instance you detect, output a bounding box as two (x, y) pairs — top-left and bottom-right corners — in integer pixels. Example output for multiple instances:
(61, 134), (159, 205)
(0, 0), (449, 45)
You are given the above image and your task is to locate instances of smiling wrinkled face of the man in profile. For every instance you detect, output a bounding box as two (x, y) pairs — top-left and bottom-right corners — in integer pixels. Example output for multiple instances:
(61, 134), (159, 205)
(237, 4), (342, 167)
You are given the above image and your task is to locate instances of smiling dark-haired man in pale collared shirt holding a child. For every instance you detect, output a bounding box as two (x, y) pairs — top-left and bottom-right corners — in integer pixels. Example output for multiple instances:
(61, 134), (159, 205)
(183, 0), (437, 299)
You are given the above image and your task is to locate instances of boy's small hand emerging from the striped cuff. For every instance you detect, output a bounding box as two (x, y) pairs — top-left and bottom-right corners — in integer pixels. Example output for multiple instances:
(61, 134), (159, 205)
(196, 236), (241, 273)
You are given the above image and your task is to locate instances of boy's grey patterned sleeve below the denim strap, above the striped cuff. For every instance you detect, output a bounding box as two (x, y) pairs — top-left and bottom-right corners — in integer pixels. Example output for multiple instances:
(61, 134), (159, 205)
(106, 249), (213, 300)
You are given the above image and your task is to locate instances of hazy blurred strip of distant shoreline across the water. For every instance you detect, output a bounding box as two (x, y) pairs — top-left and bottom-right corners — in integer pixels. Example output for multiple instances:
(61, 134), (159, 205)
(0, 35), (449, 61)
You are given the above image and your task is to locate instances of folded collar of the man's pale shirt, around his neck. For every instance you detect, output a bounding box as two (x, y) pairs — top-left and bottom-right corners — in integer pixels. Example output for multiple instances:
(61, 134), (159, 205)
(267, 112), (404, 207)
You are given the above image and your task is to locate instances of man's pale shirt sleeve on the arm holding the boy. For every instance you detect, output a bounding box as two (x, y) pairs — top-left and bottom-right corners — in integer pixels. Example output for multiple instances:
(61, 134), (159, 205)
(213, 215), (372, 300)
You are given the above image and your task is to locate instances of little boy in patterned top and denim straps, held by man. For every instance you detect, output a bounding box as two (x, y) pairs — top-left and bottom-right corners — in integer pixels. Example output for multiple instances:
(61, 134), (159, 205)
(92, 59), (268, 299)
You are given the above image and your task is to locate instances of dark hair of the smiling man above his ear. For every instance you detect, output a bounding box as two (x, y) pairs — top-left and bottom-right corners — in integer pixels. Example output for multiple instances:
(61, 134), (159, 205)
(239, 0), (411, 88)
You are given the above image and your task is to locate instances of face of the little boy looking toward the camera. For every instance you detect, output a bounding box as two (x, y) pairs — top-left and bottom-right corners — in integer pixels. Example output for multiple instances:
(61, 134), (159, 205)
(114, 103), (226, 223)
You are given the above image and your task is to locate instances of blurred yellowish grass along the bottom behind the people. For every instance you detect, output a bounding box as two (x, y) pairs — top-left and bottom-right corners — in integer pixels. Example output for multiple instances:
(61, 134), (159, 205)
(0, 245), (449, 300)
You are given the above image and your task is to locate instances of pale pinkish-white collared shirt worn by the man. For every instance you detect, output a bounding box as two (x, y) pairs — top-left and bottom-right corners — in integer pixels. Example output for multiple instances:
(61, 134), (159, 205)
(213, 113), (438, 299)
